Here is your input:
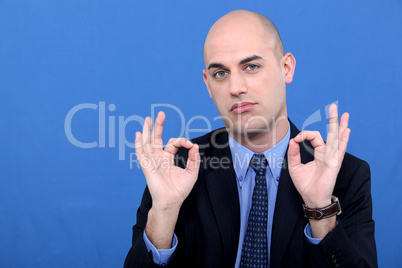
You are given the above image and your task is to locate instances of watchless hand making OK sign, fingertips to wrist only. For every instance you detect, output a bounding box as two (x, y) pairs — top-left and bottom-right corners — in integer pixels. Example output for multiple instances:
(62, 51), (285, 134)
(135, 112), (200, 208)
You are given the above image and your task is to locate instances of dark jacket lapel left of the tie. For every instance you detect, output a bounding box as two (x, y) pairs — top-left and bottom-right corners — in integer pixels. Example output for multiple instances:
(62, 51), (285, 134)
(205, 129), (240, 267)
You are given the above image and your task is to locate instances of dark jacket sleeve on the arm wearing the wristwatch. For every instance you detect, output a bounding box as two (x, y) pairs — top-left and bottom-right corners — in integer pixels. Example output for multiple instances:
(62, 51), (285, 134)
(305, 157), (378, 267)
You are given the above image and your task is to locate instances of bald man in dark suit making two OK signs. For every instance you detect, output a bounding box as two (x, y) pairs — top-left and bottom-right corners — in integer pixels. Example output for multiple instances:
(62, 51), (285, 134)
(125, 10), (377, 267)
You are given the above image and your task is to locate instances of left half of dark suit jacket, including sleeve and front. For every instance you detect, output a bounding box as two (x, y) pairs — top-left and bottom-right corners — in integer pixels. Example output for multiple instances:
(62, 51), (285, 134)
(124, 130), (240, 268)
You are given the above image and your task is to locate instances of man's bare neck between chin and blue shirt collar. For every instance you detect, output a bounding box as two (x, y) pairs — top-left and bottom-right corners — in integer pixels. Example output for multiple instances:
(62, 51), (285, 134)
(228, 116), (289, 153)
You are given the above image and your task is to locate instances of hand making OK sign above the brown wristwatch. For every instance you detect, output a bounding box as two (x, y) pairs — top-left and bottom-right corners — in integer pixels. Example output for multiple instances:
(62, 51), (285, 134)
(288, 104), (350, 208)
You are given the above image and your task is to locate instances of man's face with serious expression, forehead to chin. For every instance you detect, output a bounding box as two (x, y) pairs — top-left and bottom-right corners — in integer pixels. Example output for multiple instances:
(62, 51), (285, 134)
(204, 17), (294, 141)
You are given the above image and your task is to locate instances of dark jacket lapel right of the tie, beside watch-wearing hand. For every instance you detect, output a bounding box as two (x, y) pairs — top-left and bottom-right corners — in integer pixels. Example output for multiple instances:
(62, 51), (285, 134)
(270, 122), (313, 268)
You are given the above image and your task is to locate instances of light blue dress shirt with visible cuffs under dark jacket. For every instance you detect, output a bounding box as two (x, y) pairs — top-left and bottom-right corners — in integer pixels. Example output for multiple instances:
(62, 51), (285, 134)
(143, 123), (321, 267)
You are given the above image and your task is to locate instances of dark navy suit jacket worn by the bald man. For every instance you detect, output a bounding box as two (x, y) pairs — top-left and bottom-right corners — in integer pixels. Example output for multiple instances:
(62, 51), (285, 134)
(125, 123), (377, 268)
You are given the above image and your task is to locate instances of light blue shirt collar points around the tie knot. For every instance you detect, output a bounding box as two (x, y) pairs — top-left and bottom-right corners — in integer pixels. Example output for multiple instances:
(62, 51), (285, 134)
(229, 121), (290, 185)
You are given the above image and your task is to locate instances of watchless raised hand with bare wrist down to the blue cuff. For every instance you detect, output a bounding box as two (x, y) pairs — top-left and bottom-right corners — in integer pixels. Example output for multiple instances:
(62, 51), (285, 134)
(135, 112), (200, 249)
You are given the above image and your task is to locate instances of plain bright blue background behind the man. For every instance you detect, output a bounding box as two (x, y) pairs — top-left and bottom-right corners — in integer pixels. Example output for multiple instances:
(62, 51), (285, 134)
(0, 0), (402, 267)
